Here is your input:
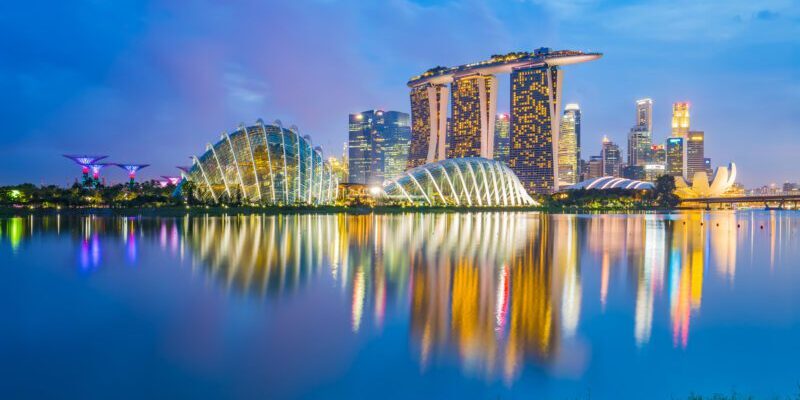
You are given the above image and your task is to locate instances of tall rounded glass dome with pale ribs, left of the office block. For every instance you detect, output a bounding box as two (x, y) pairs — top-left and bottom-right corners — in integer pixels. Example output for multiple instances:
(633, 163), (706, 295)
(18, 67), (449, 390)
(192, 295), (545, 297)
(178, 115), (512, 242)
(186, 120), (338, 204)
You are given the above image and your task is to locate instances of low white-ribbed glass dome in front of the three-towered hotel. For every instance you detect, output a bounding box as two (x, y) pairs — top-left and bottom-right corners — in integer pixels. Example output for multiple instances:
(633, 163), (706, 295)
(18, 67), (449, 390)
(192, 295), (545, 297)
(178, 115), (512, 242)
(383, 157), (537, 207)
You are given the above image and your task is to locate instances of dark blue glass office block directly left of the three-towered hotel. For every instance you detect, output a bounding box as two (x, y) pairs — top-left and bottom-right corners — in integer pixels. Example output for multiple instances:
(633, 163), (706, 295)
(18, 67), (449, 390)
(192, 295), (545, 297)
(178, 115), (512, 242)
(348, 110), (411, 185)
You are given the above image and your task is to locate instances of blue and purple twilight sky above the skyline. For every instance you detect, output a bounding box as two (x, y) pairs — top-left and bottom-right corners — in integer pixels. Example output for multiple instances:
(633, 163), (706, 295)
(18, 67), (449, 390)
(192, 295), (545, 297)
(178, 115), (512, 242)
(0, 0), (800, 187)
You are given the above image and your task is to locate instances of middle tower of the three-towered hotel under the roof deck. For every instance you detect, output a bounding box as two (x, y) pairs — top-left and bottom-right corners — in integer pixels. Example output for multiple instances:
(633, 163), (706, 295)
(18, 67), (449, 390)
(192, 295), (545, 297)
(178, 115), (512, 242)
(447, 74), (497, 159)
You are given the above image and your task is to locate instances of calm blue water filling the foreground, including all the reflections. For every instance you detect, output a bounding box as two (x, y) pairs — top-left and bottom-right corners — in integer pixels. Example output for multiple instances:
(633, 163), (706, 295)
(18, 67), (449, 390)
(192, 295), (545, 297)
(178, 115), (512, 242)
(0, 211), (800, 399)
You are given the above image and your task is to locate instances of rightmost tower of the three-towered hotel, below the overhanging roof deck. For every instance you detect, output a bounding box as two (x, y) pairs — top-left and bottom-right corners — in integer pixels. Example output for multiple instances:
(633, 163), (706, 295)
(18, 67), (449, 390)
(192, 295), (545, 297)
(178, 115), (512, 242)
(508, 64), (562, 194)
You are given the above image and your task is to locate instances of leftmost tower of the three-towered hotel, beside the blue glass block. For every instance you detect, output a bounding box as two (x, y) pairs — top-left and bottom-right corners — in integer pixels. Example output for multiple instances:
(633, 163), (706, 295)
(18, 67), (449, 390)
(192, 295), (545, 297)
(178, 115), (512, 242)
(406, 83), (450, 168)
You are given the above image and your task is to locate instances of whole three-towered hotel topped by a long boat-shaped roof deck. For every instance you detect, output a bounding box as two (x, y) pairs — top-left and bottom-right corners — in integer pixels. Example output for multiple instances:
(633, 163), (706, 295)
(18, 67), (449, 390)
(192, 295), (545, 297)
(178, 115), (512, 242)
(408, 48), (602, 194)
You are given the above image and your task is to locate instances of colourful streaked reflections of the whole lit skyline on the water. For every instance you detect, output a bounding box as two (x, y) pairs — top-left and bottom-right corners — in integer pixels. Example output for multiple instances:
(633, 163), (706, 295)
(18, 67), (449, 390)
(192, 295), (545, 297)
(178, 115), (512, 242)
(0, 212), (798, 384)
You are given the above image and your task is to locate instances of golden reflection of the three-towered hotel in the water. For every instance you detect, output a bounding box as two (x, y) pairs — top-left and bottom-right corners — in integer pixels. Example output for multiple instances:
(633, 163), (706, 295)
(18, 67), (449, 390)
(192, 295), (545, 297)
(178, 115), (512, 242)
(411, 214), (580, 380)
